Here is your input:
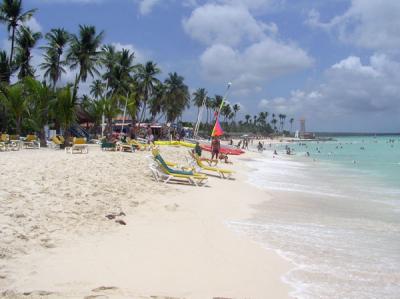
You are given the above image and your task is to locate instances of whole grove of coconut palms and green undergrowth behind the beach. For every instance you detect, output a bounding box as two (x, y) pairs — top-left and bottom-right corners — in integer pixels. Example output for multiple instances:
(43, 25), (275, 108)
(0, 0), (294, 146)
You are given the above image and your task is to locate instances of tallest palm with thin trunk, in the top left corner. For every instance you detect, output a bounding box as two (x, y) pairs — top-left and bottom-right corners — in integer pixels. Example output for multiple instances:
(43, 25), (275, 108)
(0, 0), (36, 66)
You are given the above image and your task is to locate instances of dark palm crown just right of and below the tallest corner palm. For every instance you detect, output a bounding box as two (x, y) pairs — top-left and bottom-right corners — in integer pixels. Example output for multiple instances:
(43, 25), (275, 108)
(16, 26), (42, 79)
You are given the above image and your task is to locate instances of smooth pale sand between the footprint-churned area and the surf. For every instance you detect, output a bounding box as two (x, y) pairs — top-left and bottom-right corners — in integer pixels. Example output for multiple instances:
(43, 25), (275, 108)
(0, 148), (292, 298)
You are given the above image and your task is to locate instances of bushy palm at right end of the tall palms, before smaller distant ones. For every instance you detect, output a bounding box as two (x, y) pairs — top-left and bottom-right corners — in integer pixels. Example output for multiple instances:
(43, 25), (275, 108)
(164, 73), (190, 122)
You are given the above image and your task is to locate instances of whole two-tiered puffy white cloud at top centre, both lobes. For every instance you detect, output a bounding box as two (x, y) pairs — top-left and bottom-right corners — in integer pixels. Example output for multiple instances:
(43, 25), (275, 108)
(183, 1), (313, 95)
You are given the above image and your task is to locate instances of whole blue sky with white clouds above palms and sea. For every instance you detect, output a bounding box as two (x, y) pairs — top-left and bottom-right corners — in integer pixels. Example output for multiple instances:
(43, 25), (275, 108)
(0, 0), (400, 132)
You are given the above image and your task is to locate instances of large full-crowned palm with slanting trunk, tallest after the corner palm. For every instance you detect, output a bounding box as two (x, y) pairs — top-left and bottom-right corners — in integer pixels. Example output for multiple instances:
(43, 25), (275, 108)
(67, 25), (104, 97)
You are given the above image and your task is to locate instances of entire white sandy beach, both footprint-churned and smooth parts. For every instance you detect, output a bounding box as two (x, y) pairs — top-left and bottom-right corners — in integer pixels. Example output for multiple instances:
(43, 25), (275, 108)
(0, 147), (290, 298)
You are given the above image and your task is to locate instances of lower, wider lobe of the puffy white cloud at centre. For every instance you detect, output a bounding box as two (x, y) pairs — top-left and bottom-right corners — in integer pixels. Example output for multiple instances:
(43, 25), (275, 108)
(200, 38), (313, 93)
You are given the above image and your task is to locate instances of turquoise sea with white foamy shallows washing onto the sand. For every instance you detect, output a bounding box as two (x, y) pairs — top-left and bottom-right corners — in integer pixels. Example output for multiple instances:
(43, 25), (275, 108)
(230, 136), (400, 298)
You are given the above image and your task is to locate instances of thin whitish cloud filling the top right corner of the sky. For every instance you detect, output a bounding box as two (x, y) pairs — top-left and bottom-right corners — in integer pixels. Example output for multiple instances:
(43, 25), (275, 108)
(306, 0), (400, 50)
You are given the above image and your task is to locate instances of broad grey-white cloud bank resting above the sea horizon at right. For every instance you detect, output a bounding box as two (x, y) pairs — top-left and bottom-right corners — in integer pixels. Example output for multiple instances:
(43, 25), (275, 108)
(259, 54), (400, 131)
